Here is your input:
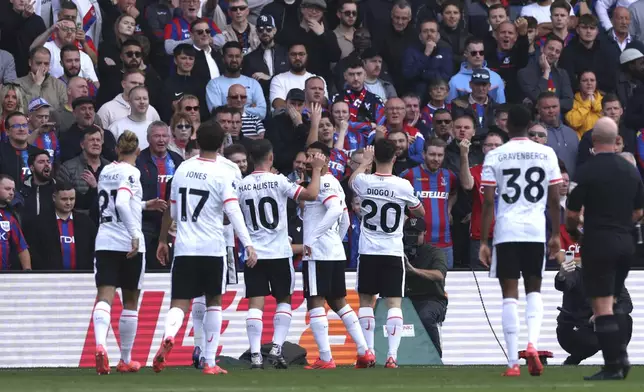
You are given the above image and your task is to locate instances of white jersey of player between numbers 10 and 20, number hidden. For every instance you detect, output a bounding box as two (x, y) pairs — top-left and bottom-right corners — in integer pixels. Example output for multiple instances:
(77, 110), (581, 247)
(302, 173), (347, 261)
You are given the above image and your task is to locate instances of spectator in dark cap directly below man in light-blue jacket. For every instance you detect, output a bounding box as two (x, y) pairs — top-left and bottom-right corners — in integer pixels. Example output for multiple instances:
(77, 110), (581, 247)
(452, 68), (497, 135)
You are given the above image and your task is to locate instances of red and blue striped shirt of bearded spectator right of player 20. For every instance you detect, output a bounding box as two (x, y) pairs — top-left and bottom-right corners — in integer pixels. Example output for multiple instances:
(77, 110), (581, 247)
(400, 164), (457, 248)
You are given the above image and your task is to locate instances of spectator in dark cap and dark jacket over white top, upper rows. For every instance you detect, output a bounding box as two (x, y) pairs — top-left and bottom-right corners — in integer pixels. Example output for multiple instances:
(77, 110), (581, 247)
(242, 15), (289, 101)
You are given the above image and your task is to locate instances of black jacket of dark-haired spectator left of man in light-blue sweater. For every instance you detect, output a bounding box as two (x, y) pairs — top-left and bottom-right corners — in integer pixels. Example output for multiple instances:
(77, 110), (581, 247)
(157, 73), (210, 124)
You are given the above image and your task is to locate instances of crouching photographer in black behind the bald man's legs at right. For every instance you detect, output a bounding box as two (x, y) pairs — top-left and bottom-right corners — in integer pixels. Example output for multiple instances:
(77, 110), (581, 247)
(555, 258), (633, 365)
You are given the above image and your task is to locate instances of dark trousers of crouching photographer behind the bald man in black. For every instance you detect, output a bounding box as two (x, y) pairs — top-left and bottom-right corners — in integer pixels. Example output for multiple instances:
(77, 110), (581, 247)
(557, 315), (633, 365)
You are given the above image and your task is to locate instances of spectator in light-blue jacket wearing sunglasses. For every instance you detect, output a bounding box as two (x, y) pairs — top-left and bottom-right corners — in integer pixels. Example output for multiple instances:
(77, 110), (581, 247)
(447, 38), (505, 103)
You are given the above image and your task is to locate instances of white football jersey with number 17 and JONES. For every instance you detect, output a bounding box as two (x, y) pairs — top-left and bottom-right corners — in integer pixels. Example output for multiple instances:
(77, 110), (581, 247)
(170, 157), (239, 257)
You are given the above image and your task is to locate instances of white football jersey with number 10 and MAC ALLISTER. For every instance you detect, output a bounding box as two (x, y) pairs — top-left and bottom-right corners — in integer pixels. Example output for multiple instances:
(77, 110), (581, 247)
(237, 171), (303, 259)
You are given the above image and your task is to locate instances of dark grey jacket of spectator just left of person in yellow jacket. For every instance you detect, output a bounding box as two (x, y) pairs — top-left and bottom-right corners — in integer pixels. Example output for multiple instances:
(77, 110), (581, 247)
(518, 57), (573, 114)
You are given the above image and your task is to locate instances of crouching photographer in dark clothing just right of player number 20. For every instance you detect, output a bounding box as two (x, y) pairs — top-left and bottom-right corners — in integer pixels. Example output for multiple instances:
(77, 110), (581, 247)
(403, 218), (447, 357)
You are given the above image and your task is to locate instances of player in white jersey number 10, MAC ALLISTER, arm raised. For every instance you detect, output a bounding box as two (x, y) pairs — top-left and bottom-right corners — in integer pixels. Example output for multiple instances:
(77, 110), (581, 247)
(238, 139), (326, 369)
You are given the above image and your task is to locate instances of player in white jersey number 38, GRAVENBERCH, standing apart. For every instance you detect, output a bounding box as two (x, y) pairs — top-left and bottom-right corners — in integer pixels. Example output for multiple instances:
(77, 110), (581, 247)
(479, 105), (562, 377)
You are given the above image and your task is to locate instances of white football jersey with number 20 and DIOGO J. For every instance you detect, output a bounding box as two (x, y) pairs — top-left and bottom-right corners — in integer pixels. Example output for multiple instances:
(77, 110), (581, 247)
(351, 174), (421, 257)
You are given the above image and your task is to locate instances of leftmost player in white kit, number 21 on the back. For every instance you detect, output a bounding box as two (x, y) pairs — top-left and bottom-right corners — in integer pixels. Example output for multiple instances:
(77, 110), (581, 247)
(93, 131), (166, 374)
